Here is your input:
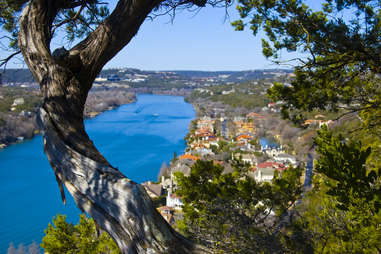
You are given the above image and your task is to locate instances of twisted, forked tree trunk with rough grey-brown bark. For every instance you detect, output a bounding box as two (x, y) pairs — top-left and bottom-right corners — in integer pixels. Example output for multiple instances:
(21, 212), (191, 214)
(19, 0), (209, 253)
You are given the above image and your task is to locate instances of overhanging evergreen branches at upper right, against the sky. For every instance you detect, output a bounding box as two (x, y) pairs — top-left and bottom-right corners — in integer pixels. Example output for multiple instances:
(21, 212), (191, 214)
(233, 0), (381, 130)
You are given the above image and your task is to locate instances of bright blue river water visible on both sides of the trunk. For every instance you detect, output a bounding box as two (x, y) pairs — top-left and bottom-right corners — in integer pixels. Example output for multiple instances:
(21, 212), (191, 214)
(0, 94), (195, 254)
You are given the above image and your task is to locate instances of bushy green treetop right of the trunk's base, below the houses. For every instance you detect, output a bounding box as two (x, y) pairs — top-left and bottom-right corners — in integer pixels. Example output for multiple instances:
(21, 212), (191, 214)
(175, 160), (309, 253)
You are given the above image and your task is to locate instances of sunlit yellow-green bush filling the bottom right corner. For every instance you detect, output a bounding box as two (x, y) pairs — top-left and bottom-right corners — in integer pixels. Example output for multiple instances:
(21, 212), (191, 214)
(299, 175), (381, 253)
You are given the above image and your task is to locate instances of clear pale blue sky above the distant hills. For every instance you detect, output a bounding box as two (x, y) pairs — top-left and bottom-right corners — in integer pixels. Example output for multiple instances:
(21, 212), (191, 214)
(1, 0), (321, 71)
